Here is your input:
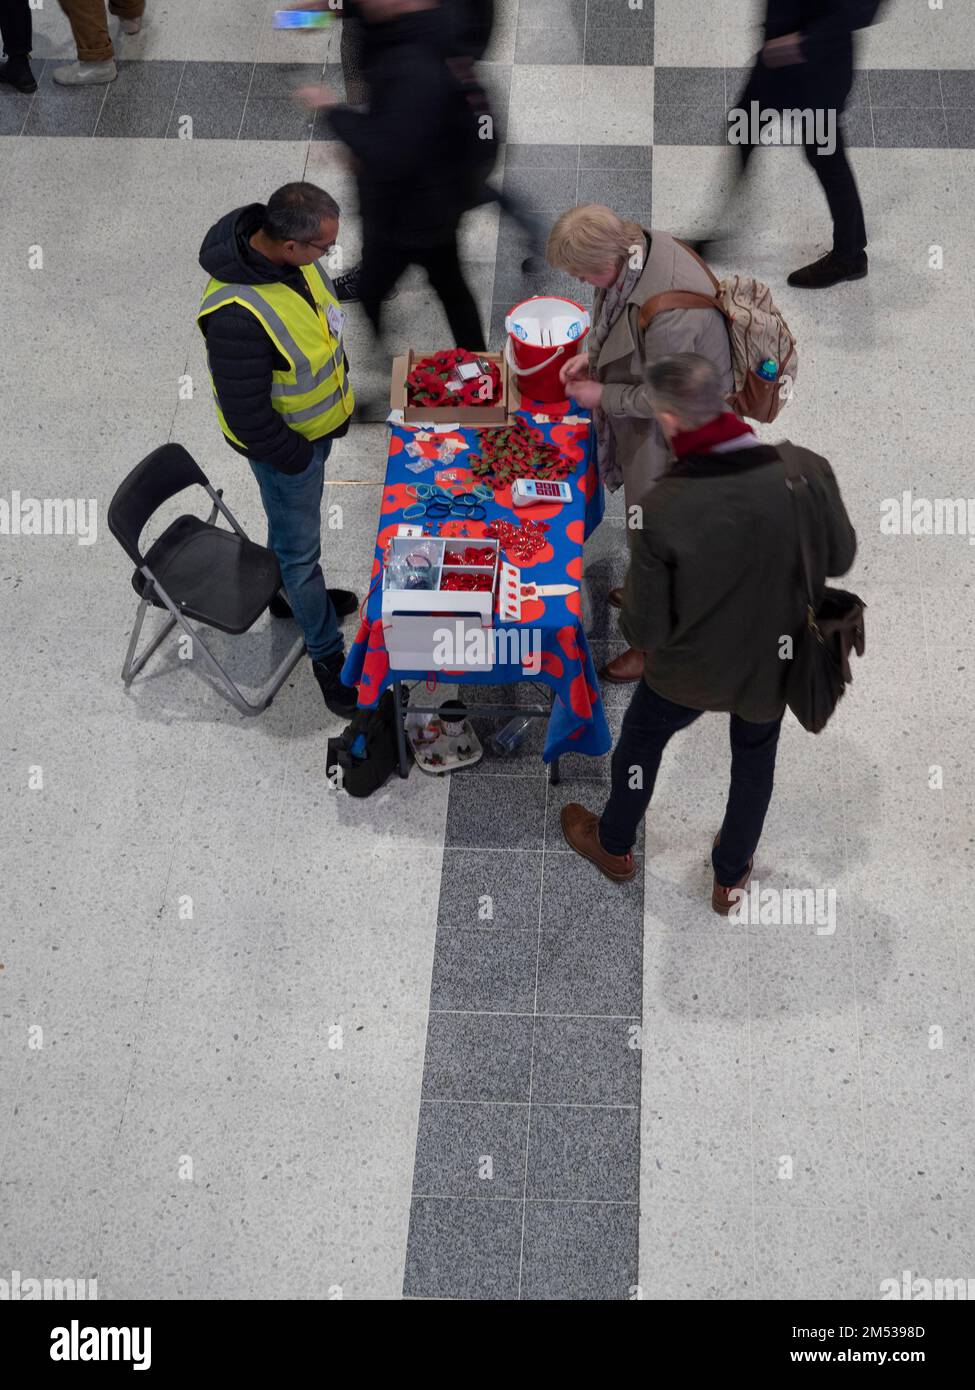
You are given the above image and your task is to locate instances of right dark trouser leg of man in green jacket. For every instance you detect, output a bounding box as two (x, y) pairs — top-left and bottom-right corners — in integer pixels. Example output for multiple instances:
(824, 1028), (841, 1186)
(711, 714), (782, 888)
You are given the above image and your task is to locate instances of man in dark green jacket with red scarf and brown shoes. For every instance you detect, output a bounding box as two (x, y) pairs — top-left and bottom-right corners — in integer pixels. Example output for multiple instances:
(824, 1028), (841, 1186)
(562, 353), (857, 913)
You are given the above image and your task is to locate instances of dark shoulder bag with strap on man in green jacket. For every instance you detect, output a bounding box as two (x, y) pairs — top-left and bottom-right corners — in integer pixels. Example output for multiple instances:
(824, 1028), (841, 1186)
(777, 445), (867, 734)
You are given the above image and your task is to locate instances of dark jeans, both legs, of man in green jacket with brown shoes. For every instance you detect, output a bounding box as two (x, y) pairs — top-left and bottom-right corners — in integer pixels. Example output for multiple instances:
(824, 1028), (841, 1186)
(599, 681), (782, 888)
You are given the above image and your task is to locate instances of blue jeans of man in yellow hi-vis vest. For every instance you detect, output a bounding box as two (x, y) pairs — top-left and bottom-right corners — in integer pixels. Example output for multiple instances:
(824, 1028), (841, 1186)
(248, 435), (345, 662)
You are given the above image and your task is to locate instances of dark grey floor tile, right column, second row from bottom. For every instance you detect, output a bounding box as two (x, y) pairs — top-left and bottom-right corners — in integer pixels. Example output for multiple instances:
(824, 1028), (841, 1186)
(527, 1105), (640, 1202)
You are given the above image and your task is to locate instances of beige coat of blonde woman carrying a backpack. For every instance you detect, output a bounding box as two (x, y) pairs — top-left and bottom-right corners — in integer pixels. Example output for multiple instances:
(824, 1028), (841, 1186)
(590, 231), (734, 507)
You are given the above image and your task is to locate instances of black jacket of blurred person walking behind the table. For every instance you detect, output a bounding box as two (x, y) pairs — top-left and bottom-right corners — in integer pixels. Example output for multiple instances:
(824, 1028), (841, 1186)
(328, 10), (477, 247)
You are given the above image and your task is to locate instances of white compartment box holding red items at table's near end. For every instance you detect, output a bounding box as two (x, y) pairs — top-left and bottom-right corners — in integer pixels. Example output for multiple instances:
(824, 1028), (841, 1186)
(382, 537), (501, 671)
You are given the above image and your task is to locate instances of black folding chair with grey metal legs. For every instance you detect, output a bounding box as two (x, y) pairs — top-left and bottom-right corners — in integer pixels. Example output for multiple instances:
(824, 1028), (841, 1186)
(108, 443), (305, 714)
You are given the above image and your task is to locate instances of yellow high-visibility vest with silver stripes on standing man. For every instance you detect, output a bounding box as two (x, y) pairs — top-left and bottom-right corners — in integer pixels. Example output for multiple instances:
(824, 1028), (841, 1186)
(196, 263), (356, 450)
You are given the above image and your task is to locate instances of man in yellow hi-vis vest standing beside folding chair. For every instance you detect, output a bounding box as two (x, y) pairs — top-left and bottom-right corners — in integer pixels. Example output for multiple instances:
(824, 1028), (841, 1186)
(198, 183), (359, 716)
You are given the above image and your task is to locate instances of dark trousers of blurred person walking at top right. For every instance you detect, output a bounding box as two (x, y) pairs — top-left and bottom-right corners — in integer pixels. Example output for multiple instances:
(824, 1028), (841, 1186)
(737, 63), (867, 261)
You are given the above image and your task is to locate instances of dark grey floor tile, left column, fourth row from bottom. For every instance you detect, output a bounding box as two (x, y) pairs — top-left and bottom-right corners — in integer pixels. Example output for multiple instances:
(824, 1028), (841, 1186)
(430, 927), (539, 1013)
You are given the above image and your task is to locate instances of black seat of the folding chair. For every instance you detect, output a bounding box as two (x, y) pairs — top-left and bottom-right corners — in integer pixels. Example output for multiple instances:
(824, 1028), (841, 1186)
(132, 516), (281, 632)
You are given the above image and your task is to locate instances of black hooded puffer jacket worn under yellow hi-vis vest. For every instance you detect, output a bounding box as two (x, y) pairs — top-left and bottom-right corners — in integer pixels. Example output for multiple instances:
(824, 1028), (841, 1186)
(200, 203), (349, 473)
